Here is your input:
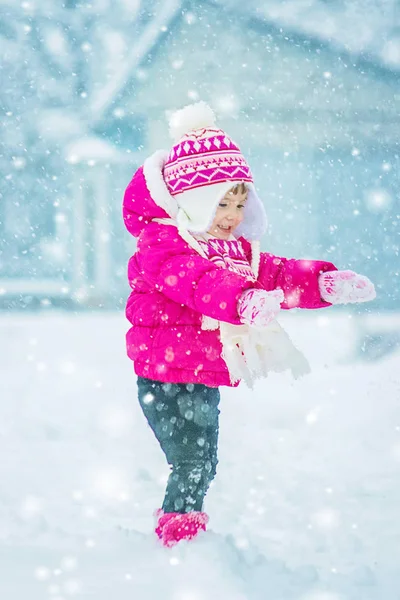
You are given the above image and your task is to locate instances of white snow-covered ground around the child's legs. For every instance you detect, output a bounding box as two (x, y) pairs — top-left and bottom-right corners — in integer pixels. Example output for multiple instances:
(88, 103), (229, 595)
(0, 310), (400, 600)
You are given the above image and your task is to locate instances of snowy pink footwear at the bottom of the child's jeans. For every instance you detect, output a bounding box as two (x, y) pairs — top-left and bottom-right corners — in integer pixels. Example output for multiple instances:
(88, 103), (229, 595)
(155, 509), (208, 548)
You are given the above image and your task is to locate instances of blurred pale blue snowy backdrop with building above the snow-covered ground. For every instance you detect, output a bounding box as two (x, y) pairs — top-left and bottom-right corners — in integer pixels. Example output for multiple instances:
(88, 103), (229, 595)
(0, 0), (400, 314)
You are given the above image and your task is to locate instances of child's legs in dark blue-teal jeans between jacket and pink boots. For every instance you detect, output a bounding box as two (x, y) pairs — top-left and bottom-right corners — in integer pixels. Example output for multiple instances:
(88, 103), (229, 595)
(138, 377), (220, 513)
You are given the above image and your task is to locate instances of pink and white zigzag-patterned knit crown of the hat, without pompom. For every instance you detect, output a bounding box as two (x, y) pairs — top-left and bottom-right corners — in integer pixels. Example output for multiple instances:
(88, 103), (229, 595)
(163, 127), (253, 196)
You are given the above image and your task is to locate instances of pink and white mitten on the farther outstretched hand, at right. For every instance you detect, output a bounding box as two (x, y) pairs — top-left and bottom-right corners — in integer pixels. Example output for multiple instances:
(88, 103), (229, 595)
(318, 271), (376, 304)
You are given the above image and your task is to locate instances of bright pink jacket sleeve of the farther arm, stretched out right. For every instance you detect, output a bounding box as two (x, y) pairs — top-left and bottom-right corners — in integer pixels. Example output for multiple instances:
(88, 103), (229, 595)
(258, 252), (337, 309)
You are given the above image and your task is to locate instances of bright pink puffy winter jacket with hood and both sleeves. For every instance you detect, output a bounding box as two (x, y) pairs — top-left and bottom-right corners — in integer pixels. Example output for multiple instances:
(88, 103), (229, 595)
(123, 167), (336, 387)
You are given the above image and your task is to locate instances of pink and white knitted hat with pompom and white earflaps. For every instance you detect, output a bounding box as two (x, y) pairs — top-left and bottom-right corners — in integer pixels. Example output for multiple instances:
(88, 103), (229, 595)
(163, 102), (266, 239)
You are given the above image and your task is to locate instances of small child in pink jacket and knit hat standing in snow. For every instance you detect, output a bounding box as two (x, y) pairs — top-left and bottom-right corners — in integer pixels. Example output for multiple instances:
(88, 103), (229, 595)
(123, 102), (375, 546)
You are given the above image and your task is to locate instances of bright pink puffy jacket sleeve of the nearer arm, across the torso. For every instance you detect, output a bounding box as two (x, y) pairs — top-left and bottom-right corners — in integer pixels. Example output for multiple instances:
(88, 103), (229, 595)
(136, 223), (261, 325)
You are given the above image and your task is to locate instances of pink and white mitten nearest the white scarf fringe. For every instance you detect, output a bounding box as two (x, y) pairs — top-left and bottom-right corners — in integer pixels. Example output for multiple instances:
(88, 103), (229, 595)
(238, 289), (284, 327)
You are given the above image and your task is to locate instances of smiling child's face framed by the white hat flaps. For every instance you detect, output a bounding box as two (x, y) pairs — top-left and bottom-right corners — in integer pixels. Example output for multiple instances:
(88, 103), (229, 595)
(207, 184), (247, 240)
